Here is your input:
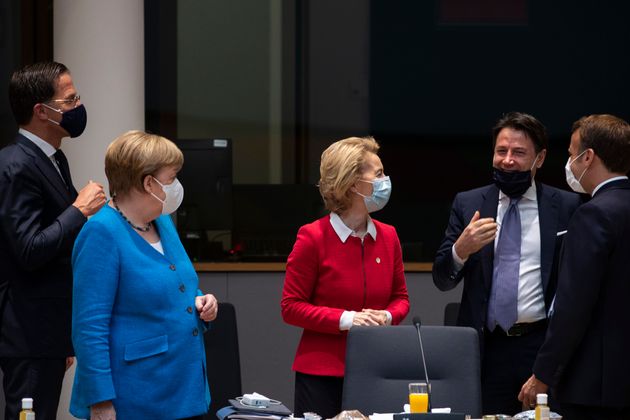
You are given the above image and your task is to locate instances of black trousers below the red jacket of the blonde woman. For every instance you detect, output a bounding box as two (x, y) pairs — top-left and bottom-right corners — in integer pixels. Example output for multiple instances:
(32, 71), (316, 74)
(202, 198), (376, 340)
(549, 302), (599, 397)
(293, 372), (343, 419)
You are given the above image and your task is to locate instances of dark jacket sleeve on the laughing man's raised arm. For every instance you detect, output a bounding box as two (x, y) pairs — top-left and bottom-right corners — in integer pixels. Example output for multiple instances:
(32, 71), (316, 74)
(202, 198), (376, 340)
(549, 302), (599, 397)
(432, 194), (468, 291)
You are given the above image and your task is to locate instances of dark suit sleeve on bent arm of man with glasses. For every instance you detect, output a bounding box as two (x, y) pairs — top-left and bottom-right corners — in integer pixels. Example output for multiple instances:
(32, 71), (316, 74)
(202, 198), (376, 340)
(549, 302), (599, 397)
(0, 158), (87, 270)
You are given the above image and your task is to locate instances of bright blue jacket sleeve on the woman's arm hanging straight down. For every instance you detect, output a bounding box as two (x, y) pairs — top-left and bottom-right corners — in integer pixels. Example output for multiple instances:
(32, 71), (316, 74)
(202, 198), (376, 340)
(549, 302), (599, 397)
(72, 223), (120, 406)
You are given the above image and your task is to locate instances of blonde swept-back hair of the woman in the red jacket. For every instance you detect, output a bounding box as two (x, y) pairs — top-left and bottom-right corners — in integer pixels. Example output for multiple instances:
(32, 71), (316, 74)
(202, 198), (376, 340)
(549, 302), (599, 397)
(319, 137), (379, 214)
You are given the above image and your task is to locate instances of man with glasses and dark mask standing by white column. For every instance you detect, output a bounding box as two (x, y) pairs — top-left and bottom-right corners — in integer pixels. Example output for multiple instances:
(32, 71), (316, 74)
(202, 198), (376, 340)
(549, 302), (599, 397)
(0, 62), (105, 420)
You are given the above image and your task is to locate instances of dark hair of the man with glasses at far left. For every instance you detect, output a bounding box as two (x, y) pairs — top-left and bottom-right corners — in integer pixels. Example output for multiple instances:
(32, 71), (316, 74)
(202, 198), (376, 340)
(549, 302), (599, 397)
(9, 61), (70, 125)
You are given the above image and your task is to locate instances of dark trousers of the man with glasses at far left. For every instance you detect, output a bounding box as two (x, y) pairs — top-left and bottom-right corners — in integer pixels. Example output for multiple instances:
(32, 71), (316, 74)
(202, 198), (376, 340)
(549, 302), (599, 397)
(0, 358), (66, 420)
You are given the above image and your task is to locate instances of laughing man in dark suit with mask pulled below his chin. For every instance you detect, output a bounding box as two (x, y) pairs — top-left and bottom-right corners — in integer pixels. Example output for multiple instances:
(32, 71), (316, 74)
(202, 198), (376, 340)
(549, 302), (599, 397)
(433, 112), (580, 415)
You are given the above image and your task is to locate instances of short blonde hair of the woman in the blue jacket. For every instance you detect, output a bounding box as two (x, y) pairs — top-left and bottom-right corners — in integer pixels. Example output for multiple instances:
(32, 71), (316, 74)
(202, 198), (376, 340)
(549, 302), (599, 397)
(105, 130), (184, 196)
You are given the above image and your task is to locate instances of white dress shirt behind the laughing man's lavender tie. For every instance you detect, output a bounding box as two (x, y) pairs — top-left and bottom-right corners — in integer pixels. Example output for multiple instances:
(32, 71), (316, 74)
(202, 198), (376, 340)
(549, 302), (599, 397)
(451, 182), (546, 322)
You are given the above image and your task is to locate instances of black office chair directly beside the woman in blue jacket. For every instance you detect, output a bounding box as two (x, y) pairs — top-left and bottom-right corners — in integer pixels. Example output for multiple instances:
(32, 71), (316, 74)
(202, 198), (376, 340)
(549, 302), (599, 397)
(204, 302), (242, 420)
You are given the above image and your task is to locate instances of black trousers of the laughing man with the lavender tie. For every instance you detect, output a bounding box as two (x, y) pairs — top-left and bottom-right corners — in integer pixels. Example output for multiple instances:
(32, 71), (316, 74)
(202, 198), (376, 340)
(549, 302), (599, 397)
(481, 327), (555, 416)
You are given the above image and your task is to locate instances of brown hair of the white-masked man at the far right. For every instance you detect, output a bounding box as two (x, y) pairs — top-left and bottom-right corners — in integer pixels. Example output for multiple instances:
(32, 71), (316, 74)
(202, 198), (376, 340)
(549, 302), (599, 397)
(571, 114), (630, 174)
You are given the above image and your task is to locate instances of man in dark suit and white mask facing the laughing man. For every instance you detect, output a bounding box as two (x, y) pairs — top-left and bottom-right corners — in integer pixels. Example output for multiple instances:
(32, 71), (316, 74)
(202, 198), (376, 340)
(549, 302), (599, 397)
(519, 115), (630, 419)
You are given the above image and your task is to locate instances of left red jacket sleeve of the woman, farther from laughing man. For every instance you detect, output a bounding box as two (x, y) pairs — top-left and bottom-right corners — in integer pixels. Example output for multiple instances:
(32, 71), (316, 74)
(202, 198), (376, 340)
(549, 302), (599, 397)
(281, 226), (348, 334)
